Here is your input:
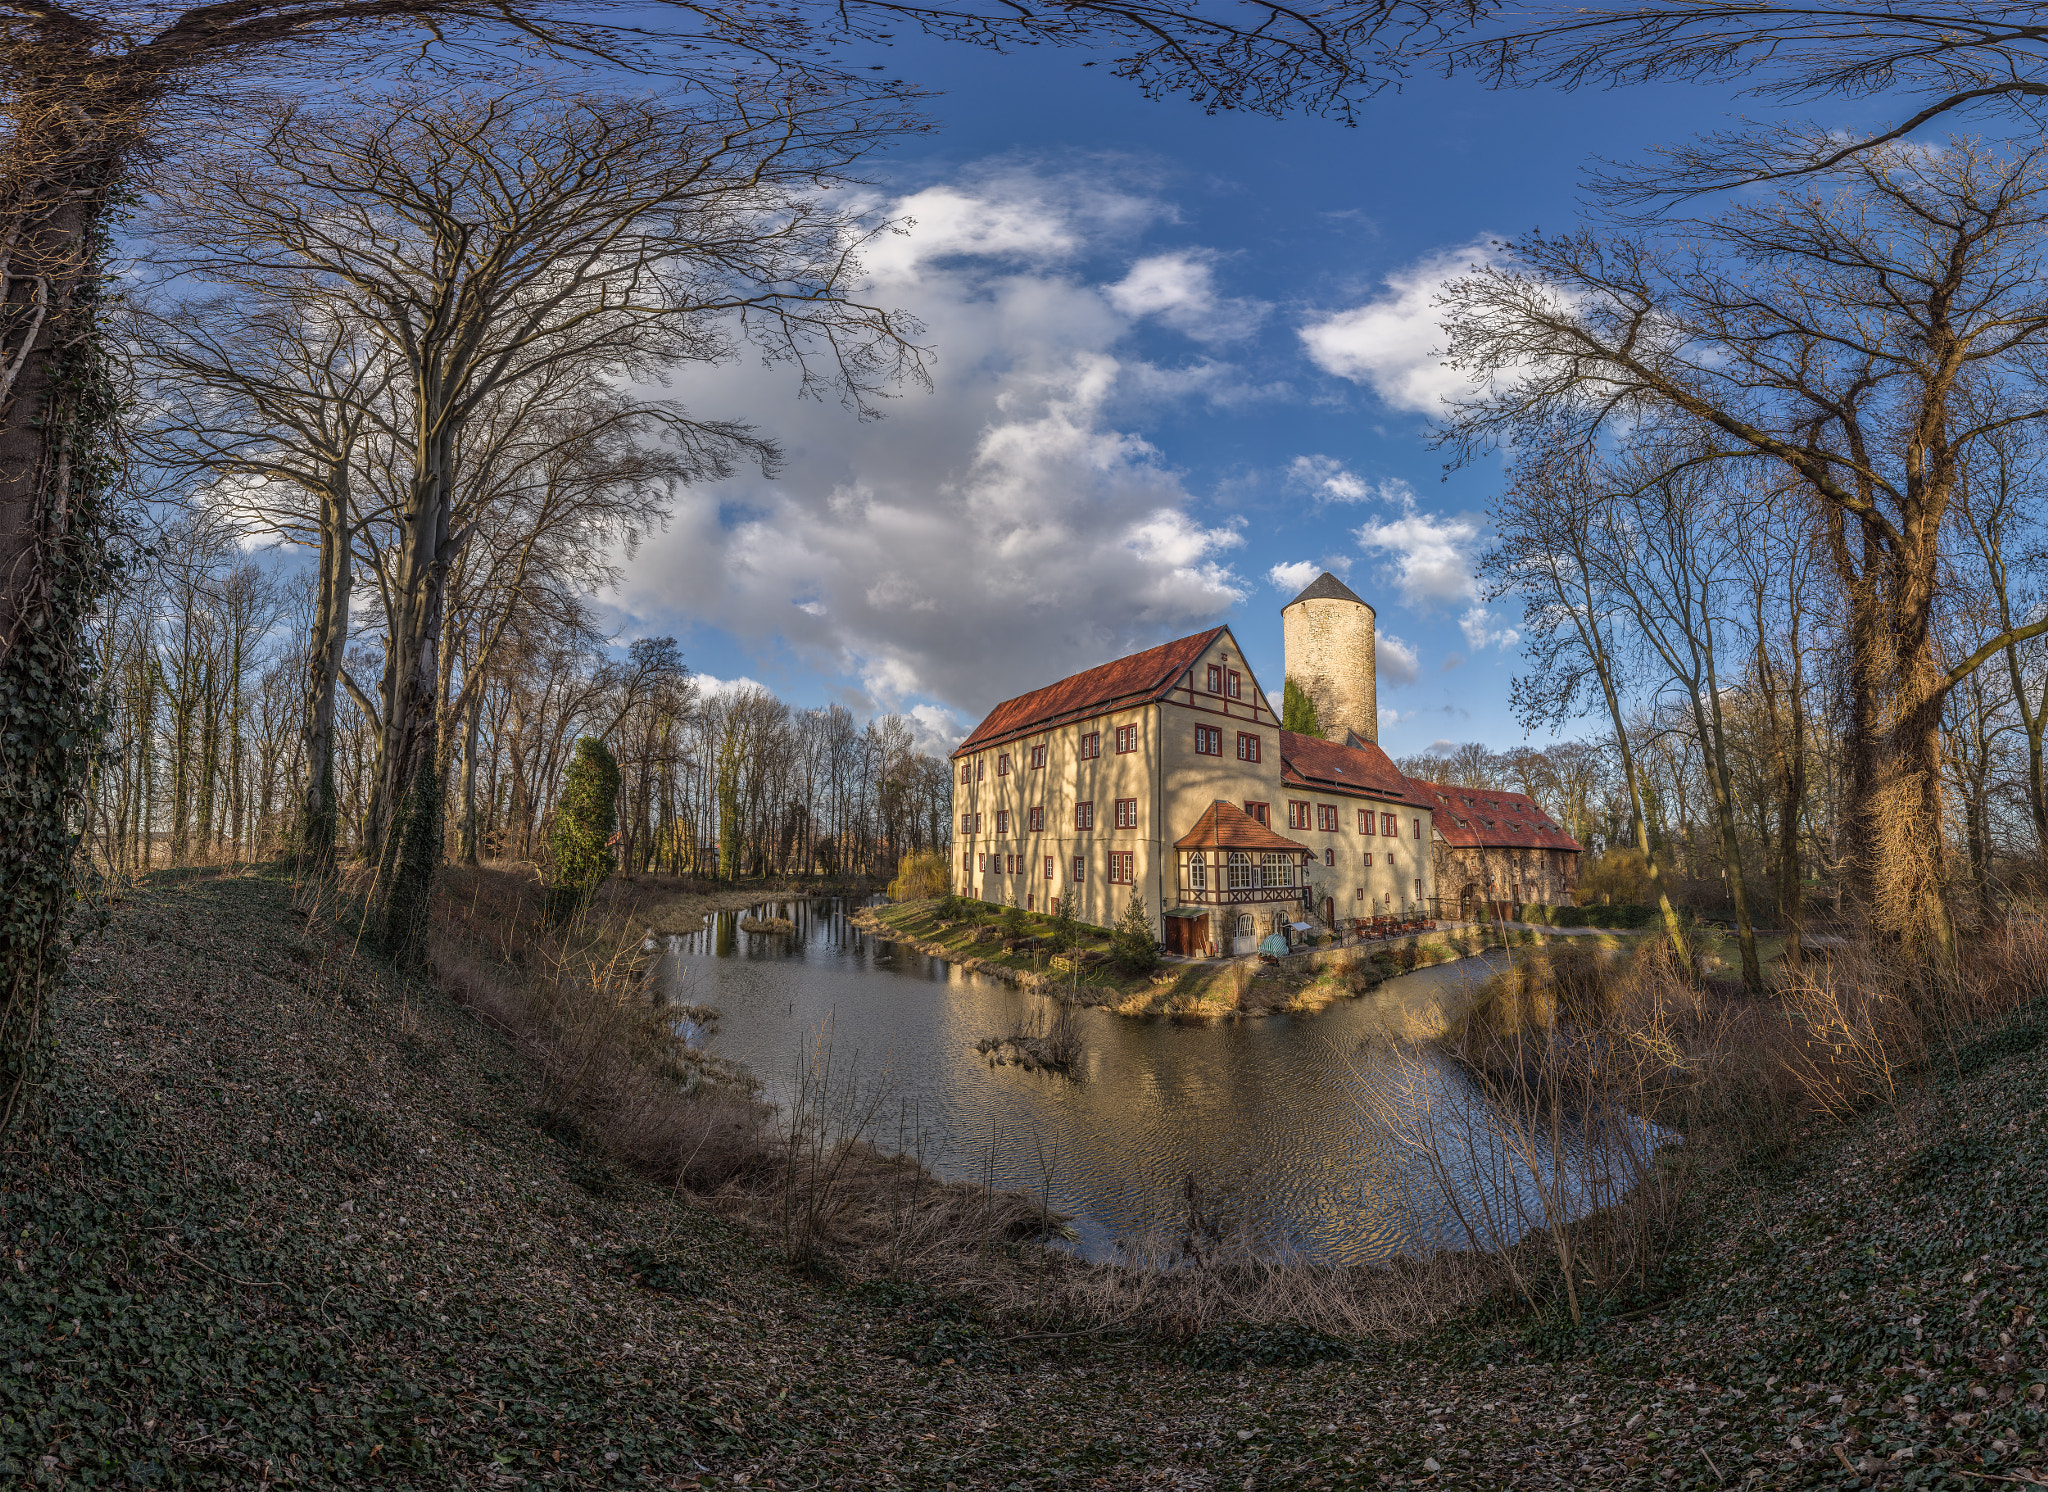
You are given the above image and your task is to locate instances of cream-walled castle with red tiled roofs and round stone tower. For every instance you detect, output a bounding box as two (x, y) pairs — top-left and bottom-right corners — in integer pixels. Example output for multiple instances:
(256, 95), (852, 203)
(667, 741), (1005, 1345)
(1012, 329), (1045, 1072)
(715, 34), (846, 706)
(952, 571), (1579, 954)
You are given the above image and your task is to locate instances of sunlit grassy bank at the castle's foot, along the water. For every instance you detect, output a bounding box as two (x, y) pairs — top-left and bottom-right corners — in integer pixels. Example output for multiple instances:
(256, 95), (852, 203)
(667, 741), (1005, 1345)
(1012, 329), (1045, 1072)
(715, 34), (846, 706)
(856, 901), (1540, 1019)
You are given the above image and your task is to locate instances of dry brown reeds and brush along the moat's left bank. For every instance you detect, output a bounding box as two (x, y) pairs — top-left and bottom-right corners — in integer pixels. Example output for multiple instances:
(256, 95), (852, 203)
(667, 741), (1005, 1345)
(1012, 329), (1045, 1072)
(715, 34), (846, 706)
(362, 866), (1061, 1271)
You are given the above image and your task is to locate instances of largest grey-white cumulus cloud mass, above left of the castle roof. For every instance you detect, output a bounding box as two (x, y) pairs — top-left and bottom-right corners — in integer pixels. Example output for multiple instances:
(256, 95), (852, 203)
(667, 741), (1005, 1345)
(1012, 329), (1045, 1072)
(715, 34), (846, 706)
(621, 159), (1247, 720)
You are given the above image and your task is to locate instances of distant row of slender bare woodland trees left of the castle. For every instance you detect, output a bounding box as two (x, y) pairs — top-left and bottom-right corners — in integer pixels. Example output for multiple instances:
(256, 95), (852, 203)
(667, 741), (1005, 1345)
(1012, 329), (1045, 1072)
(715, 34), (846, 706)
(88, 514), (950, 880)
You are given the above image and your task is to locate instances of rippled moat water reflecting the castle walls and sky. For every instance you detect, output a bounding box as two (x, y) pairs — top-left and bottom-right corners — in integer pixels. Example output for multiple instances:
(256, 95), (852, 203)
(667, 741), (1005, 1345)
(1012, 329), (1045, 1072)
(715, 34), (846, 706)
(657, 898), (1622, 1263)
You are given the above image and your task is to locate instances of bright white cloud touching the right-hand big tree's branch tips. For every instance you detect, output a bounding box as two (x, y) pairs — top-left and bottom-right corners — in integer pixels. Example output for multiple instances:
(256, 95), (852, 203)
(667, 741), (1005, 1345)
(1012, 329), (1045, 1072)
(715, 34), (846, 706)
(1300, 237), (1493, 415)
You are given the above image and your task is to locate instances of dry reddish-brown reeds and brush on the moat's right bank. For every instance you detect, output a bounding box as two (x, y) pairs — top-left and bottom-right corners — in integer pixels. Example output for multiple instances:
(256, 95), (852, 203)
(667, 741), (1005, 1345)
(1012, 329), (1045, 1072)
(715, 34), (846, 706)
(1382, 913), (2048, 1324)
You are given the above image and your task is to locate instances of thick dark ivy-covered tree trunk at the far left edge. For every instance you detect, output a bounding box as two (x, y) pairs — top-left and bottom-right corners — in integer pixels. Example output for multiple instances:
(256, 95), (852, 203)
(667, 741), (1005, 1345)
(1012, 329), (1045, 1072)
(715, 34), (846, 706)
(0, 195), (117, 1132)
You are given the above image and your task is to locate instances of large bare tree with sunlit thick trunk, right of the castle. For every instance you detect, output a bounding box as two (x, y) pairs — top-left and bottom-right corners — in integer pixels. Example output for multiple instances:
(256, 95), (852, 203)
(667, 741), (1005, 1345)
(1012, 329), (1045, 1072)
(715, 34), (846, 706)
(1444, 145), (2048, 950)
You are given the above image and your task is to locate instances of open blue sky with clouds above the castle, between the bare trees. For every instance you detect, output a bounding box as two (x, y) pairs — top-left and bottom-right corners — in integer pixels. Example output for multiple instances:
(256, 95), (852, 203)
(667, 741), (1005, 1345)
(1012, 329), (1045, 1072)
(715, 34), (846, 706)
(608, 41), (1900, 753)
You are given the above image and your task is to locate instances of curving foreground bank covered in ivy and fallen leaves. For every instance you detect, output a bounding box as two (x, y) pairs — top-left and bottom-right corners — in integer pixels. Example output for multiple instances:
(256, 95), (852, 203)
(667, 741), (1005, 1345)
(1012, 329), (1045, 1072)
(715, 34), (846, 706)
(0, 872), (2048, 1492)
